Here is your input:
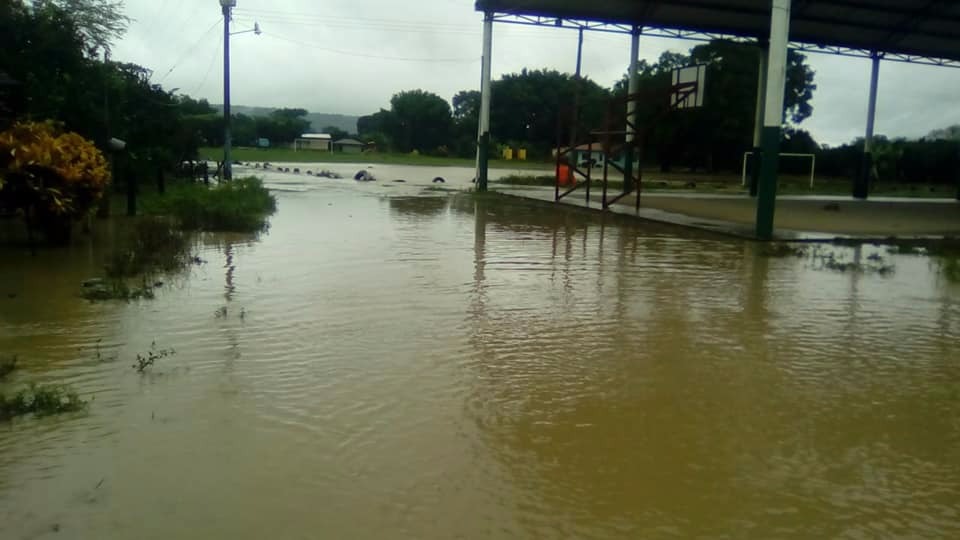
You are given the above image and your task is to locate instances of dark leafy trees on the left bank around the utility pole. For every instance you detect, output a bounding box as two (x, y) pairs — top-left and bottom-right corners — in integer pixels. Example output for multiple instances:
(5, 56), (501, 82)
(0, 0), (342, 168)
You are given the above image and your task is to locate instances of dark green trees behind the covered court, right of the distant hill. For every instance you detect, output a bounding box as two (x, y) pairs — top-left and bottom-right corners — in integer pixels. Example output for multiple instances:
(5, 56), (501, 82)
(357, 40), (960, 183)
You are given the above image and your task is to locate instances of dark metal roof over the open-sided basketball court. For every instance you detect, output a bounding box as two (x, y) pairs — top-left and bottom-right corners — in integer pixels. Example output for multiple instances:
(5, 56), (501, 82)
(476, 0), (960, 65)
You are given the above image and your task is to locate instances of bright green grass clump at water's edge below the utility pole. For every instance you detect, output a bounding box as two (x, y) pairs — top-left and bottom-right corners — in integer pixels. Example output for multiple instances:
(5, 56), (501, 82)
(143, 177), (277, 233)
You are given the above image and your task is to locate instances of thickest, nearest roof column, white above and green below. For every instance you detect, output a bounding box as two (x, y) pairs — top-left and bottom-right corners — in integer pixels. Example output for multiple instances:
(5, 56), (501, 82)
(756, 0), (790, 240)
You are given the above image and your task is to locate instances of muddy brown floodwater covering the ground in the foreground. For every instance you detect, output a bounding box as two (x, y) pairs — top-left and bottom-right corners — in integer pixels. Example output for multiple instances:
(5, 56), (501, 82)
(0, 170), (960, 539)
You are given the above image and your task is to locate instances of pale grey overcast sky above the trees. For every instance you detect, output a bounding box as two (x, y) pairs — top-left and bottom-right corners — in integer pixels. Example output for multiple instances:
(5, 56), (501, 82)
(114, 0), (960, 145)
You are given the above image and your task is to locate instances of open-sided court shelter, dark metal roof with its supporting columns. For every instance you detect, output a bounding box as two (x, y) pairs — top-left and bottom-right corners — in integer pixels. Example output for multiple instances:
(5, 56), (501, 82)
(476, 0), (960, 239)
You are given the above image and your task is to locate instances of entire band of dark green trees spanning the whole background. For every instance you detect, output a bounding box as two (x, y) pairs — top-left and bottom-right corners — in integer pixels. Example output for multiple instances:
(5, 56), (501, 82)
(0, 0), (960, 186)
